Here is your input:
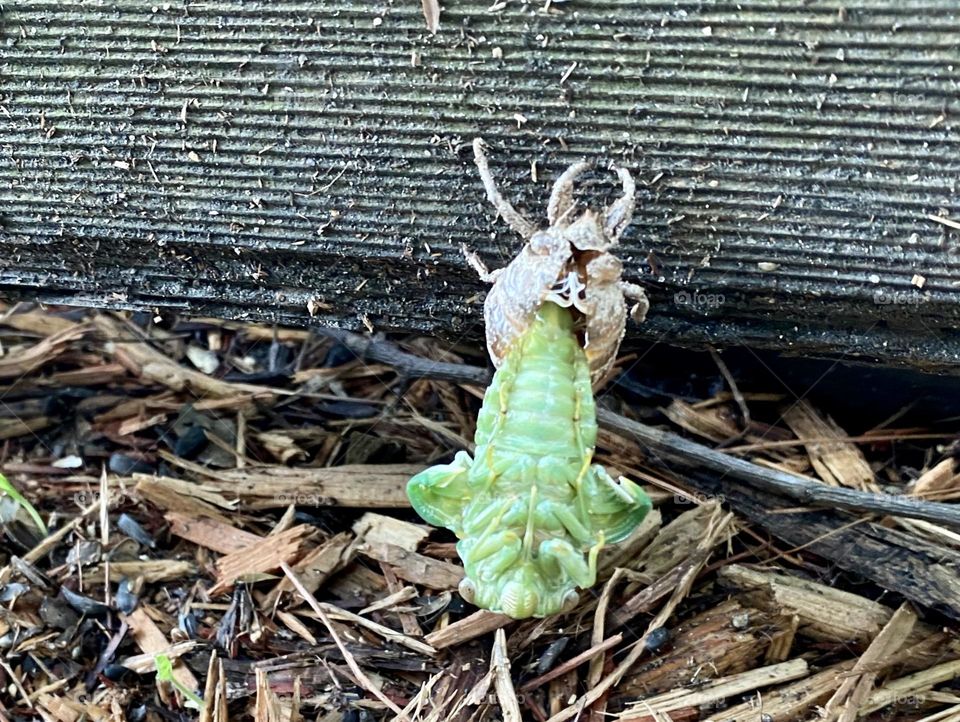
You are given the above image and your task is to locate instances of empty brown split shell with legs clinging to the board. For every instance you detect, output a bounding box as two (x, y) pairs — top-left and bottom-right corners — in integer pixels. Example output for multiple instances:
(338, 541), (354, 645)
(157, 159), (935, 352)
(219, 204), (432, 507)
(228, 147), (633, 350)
(464, 138), (649, 383)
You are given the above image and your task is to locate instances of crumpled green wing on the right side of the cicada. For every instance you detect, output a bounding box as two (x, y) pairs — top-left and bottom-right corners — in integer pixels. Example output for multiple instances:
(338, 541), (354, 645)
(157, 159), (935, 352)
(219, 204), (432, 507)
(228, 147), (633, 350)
(582, 464), (653, 544)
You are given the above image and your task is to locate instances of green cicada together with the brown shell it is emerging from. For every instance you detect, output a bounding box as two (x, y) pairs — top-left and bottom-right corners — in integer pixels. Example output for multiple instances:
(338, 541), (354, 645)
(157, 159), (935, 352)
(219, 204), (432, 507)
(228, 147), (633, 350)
(408, 139), (651, 619)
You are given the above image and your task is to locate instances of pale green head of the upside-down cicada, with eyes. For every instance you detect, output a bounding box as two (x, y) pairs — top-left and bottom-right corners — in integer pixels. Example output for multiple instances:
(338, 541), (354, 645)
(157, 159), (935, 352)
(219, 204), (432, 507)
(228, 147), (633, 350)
(459, 561), (580, 619)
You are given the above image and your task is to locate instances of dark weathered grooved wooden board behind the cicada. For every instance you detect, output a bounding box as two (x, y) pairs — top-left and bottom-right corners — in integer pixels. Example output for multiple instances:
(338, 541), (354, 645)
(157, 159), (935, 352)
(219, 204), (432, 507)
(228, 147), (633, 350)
(0, 0), (960, 368)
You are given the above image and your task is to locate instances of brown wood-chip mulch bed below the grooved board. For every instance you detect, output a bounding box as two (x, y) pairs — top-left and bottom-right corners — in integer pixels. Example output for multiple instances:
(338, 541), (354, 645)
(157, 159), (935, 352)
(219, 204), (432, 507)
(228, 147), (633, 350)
(0, 307), (960, 722)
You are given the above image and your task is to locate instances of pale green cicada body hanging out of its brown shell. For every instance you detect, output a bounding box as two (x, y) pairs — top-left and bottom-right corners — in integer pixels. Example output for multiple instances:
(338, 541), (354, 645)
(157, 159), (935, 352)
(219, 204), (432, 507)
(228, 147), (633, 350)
(407, 302), (650, 619)
